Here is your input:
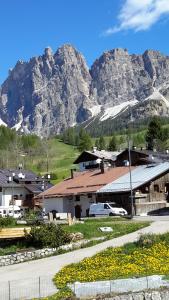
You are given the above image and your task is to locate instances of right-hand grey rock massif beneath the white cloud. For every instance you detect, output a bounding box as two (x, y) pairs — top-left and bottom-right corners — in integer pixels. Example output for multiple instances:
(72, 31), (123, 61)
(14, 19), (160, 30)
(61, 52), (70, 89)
(91, 49), (169, 106)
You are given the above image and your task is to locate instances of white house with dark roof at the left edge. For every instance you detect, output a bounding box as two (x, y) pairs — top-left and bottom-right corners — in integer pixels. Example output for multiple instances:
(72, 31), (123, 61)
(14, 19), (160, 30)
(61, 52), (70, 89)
(0, 169), (52, 208)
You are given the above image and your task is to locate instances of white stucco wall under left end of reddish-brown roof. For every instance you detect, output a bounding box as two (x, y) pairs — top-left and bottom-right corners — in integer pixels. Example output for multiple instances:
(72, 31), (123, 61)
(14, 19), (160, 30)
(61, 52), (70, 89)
(43, 198), (65, 213)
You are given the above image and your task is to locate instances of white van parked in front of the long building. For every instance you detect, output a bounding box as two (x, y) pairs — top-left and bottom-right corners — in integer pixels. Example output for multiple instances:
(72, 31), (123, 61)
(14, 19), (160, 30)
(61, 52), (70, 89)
(89, 203), (127, 217)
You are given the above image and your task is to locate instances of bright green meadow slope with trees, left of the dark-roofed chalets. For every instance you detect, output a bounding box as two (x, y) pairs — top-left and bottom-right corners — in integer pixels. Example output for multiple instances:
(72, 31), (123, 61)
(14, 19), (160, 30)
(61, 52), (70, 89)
(0, 126), (79, 182)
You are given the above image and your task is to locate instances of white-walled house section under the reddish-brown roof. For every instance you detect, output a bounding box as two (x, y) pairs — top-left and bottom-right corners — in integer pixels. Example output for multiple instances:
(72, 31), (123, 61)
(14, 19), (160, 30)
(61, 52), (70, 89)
(35, 167), (132, 218)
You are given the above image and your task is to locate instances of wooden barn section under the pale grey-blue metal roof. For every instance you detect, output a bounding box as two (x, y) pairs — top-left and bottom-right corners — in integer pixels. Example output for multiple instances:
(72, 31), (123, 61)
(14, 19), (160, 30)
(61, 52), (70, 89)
(97, 162), (169, 215)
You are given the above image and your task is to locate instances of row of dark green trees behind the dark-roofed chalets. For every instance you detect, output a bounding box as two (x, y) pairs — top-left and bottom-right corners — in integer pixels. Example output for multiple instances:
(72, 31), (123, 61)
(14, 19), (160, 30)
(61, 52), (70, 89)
(60, 116), (169, 151)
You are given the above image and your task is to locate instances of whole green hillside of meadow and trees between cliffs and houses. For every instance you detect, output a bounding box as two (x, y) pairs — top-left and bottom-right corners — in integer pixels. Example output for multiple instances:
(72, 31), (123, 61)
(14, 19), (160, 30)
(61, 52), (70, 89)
(0, 117), (169, 183)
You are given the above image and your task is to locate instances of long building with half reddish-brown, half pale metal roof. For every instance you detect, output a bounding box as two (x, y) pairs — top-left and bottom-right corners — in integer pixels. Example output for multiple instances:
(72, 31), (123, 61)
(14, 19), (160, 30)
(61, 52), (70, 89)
(35, 162), (169, 218)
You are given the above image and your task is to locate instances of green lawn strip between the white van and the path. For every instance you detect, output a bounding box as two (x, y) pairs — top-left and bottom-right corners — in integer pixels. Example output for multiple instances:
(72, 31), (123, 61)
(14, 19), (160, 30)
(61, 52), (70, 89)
(65, 217), (150, 239)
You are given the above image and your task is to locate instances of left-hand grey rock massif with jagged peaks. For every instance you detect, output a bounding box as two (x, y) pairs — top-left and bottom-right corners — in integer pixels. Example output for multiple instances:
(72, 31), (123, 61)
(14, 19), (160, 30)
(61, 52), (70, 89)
(0, 45), (91, 135)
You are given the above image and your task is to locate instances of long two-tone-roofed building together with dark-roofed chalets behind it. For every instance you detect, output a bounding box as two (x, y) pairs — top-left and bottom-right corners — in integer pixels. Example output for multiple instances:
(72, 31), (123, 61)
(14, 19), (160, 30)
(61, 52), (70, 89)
(34, 148), (169, 218)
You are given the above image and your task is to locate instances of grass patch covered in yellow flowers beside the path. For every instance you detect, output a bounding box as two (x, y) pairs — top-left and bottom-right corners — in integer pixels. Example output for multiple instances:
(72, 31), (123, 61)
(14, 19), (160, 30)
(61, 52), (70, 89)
(54, 233), (169, 289)
